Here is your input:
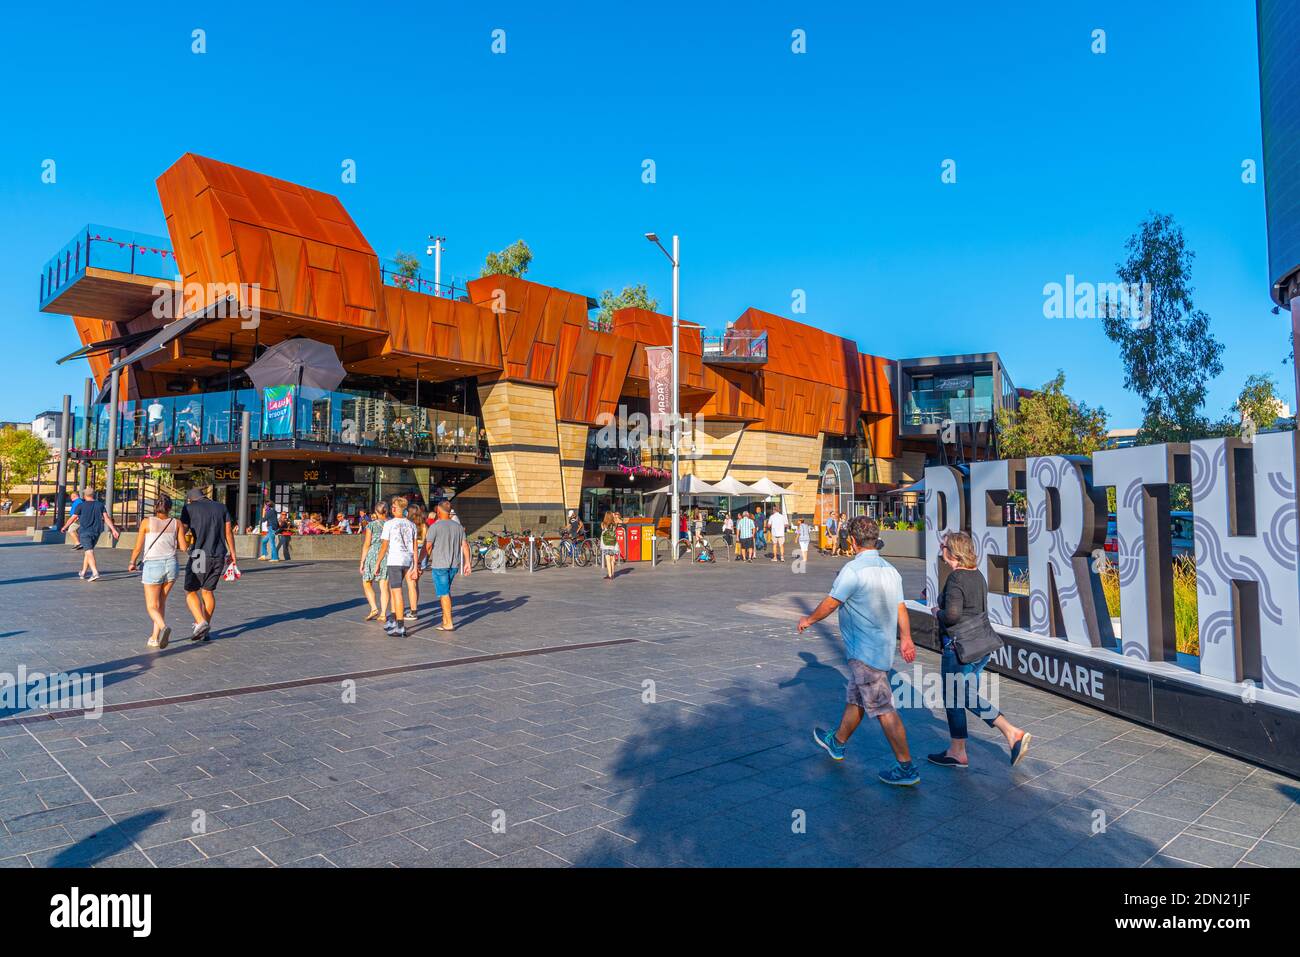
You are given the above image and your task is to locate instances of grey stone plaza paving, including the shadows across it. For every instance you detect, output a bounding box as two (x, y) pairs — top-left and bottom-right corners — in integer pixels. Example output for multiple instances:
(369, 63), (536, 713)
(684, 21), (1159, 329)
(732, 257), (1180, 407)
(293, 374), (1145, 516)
(0, 536), (1300, 867)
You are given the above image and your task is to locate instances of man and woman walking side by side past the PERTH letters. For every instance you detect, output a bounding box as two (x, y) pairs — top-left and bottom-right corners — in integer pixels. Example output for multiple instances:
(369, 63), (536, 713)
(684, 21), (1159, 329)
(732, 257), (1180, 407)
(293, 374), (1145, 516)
(798, 516), (1032, 787)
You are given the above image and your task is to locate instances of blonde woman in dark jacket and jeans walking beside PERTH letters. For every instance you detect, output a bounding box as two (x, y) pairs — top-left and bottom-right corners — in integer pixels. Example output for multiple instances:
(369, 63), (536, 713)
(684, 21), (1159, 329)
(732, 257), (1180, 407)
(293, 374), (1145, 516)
(930, 532), (1034, 768)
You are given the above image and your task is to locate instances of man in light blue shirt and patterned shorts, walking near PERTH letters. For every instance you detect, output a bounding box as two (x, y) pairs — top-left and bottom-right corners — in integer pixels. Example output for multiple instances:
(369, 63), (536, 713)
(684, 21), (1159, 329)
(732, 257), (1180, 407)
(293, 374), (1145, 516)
(800, 515), (920, 787)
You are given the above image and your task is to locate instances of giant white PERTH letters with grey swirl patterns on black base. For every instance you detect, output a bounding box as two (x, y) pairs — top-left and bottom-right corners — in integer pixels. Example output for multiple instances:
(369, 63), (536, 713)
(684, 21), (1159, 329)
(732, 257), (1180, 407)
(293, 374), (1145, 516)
(926, 432), (1300, 700)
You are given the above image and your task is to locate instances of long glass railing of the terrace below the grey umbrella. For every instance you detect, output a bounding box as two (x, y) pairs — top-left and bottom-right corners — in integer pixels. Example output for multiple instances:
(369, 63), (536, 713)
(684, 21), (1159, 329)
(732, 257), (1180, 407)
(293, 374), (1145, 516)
(77, 389), (488, 462)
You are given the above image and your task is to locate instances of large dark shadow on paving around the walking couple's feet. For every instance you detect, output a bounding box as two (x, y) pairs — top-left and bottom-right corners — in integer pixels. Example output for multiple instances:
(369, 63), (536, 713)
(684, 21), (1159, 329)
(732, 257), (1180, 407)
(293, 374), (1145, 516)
(569, 646), (1164, 867)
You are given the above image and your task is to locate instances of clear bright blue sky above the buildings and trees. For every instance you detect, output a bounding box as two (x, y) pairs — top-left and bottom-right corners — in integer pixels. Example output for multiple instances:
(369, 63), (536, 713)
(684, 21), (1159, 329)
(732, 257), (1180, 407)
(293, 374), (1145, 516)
(0, 0), (1279, 426)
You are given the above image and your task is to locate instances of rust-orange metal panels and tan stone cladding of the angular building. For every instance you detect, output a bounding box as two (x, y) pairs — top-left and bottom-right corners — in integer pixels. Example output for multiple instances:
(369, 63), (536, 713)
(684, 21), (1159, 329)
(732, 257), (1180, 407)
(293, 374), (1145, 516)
(46, 153), (920, 523)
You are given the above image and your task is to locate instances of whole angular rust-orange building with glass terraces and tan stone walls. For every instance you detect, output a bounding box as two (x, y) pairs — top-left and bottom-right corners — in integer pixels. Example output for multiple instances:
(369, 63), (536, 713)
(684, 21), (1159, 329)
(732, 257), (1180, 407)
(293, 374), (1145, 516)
(40, 153), (1014, 531)
